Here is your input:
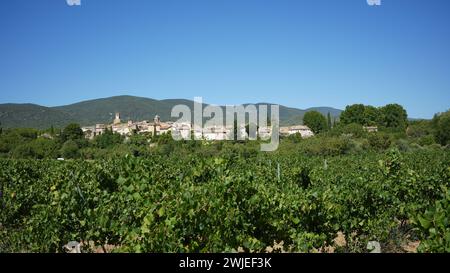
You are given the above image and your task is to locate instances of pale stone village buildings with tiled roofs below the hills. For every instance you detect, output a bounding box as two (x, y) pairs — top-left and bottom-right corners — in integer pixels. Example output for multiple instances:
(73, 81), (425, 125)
(82, 113), (314, 141)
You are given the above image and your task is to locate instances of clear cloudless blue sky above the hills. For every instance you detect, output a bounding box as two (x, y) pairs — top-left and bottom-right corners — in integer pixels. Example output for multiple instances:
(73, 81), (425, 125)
(0, 0), (450, 118)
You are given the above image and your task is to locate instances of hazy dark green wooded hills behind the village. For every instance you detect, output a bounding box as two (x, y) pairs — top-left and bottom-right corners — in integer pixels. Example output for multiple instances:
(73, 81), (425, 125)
(0, 96), (342, 129)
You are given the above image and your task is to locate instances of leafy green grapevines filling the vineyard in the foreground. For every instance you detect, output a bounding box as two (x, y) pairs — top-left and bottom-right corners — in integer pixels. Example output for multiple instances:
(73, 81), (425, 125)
(0, 150), (450, 253)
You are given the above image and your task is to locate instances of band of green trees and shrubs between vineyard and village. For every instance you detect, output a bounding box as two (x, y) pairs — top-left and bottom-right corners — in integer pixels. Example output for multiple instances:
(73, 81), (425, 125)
(0, 104), (450, 159)
